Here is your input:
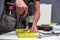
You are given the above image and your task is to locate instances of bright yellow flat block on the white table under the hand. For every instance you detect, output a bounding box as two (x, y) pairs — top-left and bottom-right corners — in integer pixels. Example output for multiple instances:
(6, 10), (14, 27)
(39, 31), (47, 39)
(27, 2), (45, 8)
(16, 29), (39, 38)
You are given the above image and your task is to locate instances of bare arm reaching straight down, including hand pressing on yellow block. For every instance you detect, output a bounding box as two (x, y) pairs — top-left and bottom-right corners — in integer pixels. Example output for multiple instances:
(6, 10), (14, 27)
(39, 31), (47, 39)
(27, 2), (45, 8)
(31, 1), (40, 32)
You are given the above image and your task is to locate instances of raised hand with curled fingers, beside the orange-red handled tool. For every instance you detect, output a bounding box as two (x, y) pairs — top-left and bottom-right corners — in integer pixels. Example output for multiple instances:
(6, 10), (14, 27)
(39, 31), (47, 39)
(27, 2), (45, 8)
(15, 0), (28, 17)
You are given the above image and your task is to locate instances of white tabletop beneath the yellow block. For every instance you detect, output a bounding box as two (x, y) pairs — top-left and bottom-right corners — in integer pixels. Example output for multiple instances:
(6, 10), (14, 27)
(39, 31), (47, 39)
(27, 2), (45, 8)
(0, 31), (60, 40)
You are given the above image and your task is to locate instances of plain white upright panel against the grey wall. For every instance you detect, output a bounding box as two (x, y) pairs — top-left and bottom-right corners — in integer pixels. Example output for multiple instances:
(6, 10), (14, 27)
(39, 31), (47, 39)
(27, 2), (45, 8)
(37, 4), (52, 25)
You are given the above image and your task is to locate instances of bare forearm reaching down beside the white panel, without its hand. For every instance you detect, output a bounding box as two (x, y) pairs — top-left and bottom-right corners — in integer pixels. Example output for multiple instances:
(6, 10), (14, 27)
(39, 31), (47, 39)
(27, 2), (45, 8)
(33, 1), (40, 26)
